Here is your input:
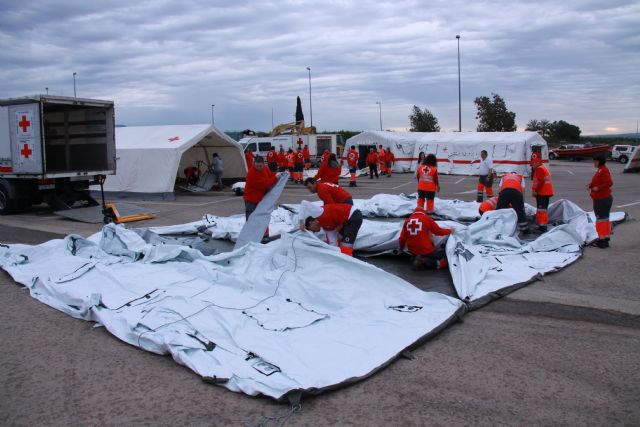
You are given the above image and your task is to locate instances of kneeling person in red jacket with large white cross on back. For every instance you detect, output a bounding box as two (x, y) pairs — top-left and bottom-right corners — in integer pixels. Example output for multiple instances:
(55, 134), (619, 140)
(398, 207), (453, 270)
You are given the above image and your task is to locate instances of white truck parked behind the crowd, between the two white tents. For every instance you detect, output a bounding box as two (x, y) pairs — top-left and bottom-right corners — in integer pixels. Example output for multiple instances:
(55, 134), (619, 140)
(238, 134), (344, 164)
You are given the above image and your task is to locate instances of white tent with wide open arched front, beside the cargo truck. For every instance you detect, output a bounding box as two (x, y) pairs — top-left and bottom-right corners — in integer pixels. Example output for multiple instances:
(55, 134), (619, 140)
(99, 124), (247, 199)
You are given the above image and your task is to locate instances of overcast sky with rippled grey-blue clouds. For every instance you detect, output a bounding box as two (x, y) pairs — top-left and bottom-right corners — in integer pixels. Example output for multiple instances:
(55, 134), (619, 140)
(0, 0), (640, 134)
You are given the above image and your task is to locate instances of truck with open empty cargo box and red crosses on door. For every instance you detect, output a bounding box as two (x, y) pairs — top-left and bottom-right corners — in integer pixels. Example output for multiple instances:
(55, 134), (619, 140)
(0, 95), (116, 214)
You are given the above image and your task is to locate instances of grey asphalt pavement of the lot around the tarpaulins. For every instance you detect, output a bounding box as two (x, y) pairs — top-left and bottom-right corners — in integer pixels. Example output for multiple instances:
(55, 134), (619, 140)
(0, 161), (640, 426)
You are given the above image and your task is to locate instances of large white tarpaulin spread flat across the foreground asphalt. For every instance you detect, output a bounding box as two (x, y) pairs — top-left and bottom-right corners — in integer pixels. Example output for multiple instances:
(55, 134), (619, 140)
(0, 224), (464, 398)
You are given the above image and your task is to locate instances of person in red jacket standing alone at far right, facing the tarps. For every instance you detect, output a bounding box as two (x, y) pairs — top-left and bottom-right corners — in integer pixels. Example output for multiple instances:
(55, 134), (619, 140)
(587, 154), (613, 249)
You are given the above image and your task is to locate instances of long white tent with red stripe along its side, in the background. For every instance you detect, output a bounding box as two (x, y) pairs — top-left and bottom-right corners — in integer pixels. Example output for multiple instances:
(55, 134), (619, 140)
(346, 131), (549, 175)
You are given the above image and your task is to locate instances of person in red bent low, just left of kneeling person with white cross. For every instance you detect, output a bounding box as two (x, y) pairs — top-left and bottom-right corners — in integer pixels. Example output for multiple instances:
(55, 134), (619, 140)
(298, 200), (362, 256)
